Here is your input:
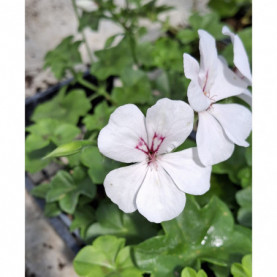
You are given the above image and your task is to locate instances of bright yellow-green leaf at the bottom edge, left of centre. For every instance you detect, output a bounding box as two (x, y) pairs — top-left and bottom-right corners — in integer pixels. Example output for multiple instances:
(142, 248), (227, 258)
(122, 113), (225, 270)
(73, 236), (143, 277)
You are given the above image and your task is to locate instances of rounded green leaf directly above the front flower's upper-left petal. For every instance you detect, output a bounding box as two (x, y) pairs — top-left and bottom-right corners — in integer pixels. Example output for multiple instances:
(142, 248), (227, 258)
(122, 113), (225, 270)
(112, 68), (152, 105)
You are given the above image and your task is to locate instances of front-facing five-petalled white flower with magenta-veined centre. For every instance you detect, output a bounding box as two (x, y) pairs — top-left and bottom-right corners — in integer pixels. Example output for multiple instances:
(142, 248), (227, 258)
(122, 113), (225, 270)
(98, 98), (211, 223)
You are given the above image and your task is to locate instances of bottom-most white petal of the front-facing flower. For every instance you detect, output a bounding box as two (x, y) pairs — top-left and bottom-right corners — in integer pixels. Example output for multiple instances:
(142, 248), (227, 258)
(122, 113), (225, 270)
(136, 166), (186, 223)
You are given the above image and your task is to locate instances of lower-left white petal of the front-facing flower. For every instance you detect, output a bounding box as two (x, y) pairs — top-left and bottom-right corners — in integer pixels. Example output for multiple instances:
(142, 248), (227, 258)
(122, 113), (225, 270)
(104, 163), (147, 213)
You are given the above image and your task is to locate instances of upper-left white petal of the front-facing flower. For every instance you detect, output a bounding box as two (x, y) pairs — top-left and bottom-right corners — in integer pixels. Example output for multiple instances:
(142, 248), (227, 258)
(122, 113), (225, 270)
(98, 104), (147, 163)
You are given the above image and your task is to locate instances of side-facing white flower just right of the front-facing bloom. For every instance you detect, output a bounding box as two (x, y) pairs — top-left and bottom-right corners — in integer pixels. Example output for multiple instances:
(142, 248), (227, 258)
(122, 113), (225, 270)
(184, 30), (251, 165)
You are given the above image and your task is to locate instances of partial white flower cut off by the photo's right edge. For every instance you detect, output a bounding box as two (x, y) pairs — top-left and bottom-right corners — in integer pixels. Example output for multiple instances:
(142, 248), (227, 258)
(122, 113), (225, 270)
(222, 26), (252, 106)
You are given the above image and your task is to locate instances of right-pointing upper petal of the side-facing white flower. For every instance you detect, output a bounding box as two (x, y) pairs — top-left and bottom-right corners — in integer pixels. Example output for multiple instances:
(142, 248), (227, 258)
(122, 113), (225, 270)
(209, 58), (247, 102)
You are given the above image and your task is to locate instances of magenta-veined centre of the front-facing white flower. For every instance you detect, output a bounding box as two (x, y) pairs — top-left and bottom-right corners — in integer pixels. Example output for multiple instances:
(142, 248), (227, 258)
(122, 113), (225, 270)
(135, 132), (165, 165)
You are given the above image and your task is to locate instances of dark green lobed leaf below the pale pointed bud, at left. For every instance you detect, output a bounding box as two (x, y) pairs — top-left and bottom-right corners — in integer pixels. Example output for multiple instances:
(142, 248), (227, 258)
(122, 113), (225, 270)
(46, 167), (96, 214)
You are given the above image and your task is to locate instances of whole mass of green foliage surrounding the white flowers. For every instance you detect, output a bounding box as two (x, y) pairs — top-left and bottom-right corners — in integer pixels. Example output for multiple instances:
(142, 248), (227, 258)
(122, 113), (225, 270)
(26, 0), (252, 277)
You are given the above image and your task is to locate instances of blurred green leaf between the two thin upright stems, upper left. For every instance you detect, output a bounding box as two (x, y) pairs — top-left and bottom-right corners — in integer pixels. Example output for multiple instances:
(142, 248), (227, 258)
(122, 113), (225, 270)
(91, 39), (133, 80)
